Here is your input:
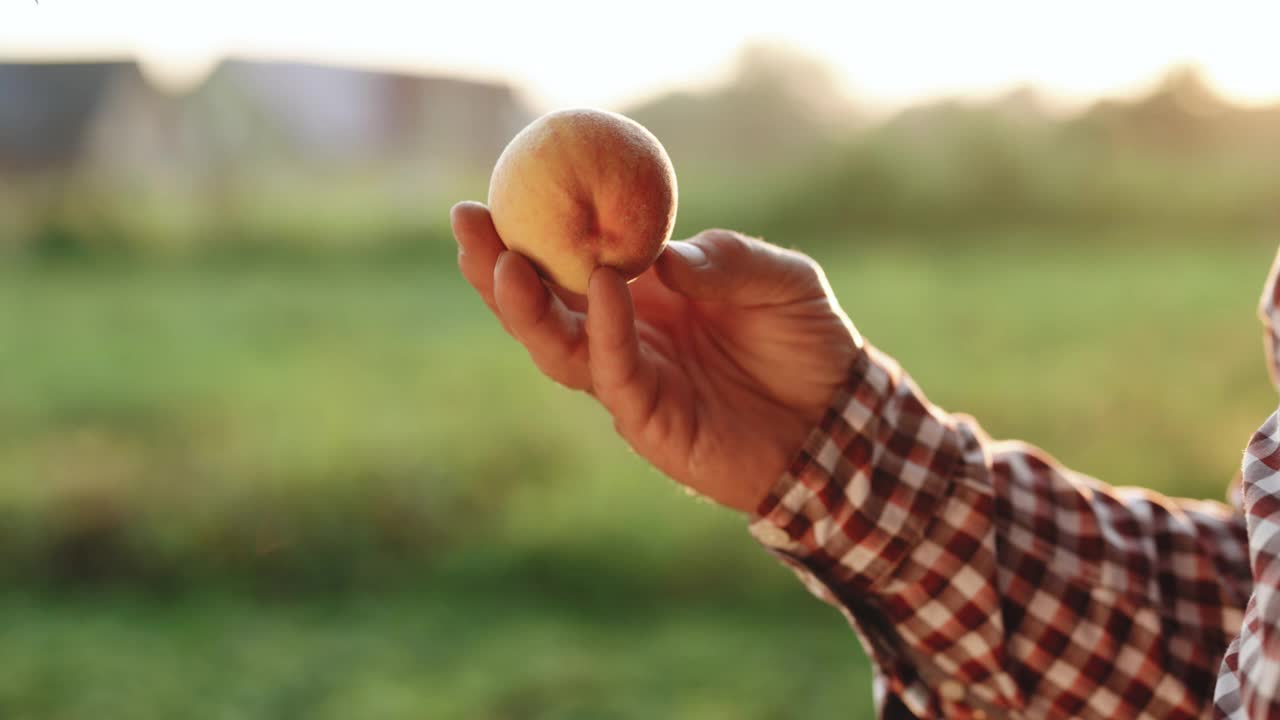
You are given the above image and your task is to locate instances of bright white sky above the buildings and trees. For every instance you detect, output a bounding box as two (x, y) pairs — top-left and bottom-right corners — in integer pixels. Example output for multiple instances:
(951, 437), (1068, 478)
(0, 0), (1280, 110)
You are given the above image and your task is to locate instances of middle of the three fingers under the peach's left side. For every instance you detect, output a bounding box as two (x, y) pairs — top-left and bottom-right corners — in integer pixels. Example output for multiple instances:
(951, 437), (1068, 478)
(492, 252), (591, 389)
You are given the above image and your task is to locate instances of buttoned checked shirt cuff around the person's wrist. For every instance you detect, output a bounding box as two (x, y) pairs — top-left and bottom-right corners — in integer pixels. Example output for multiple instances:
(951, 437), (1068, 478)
(750, 346), (963, 589)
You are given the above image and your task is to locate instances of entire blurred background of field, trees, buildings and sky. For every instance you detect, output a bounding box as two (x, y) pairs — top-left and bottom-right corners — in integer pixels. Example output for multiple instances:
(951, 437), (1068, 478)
(0, 0), (1280, 719)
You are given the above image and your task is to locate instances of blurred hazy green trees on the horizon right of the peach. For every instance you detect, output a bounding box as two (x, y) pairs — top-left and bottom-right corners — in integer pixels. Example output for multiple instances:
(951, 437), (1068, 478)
(645, 62), (1280, 240)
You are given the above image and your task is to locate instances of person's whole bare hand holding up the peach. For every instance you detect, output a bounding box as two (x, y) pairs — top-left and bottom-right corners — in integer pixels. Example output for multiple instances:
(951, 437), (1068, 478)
(452, 202), (861, 512)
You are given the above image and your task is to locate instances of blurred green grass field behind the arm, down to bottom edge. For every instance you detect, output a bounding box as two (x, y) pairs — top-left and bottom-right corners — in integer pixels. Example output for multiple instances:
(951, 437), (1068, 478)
(0, 237), (1276, 719)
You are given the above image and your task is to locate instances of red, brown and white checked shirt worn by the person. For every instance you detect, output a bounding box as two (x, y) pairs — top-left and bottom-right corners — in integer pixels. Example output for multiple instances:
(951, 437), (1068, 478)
(751, 249), (1280, 720)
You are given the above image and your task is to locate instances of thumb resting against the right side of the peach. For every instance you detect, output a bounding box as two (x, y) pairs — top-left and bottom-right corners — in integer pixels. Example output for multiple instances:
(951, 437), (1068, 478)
(655, 229), (826, 305)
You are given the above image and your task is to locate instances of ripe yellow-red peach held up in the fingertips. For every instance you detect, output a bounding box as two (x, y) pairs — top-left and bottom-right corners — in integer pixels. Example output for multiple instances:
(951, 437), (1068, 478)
(489, 109), (677, 293)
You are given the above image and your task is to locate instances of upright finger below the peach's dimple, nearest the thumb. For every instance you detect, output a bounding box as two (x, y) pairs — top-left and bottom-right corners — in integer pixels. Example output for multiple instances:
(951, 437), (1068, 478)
(586, 268), (658, 433)
